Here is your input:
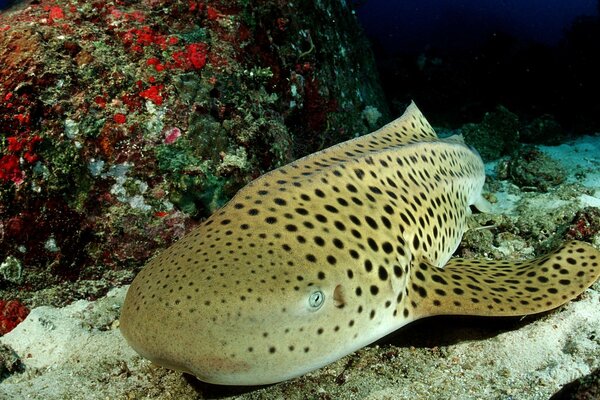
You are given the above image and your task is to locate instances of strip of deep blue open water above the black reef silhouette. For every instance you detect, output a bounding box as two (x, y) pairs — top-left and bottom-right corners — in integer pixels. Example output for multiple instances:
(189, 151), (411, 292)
(357, 0), (598, 52)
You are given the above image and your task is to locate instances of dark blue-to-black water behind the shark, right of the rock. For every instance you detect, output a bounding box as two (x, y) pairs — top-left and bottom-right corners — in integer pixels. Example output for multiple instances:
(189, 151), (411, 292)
(353, 0), (600, 132)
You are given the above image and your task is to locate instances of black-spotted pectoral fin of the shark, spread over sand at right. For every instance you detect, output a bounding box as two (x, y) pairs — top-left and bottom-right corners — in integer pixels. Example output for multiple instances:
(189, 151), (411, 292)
(407, 241), (600, 319)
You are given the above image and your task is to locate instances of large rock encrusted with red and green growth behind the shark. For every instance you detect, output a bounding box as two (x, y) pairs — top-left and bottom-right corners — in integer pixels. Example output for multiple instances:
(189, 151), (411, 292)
(0, 0), (389, 303)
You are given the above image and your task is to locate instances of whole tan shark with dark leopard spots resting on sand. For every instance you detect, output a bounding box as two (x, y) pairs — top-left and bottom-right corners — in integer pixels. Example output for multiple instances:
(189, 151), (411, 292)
(121, 104), (600, 385)
